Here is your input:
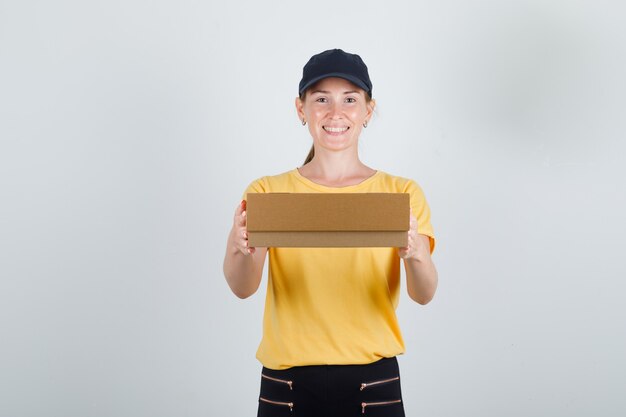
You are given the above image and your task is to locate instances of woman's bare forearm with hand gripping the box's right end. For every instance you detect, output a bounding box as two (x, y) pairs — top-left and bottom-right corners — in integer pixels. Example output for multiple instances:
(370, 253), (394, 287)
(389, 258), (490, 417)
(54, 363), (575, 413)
(398, 214), (439, 305)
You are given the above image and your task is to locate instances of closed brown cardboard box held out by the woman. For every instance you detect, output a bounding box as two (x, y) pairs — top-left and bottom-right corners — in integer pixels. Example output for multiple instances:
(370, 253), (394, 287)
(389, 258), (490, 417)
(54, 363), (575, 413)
(246, 193), (410, 247)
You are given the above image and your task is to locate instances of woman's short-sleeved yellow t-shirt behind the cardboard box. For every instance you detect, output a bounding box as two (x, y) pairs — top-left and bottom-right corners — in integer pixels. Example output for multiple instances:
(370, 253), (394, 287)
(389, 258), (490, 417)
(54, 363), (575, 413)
(246, 169), (435, 369)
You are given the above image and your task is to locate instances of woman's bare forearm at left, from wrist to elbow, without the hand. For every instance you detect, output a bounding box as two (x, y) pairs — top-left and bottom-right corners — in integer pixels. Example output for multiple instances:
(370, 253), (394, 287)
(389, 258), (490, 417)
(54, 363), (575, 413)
(224, 234), (265, 298)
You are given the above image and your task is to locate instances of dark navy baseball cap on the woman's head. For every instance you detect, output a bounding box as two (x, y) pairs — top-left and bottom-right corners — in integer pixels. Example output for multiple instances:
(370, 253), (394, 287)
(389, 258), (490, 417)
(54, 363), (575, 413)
(298, 49), (372, 97)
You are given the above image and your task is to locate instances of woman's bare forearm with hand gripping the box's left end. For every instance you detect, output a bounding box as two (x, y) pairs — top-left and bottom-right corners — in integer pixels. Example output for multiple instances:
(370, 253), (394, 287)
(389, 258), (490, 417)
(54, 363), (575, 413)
(224, 200), (267, 298)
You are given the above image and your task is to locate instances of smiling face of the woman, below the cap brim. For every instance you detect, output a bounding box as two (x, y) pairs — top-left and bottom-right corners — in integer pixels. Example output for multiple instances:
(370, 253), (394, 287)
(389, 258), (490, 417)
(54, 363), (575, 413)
(296, 77), (374, 151)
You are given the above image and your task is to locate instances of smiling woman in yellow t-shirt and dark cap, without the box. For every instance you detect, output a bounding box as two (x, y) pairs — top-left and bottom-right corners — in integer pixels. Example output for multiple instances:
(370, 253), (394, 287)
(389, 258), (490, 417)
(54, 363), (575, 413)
(224, 49), (438, 417)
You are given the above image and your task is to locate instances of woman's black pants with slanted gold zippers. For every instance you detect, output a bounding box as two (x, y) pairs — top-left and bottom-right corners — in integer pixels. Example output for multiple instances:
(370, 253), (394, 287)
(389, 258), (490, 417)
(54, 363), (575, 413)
(257, 357), (404, 417)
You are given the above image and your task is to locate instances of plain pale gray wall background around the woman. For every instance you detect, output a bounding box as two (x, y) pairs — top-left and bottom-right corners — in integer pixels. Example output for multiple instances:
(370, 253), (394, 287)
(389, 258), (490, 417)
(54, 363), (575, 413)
(0, 0), (626, 417)
